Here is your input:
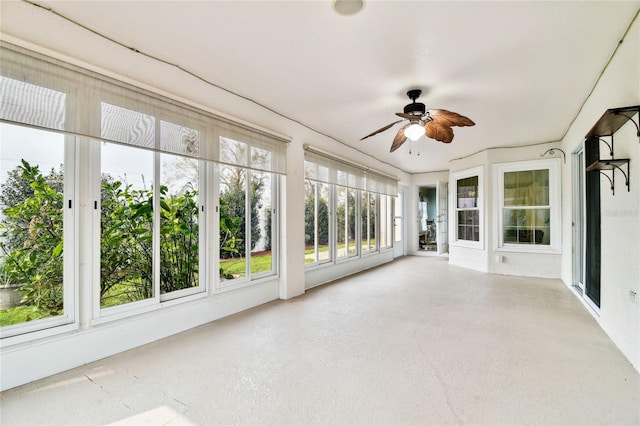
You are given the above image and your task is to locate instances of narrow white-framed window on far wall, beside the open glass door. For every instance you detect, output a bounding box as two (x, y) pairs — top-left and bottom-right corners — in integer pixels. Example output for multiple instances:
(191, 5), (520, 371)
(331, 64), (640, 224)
(450, 167), (484, 248)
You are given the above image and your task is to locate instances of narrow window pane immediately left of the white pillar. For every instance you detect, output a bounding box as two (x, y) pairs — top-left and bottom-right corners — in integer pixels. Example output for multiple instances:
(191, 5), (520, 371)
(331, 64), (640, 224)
(251, 171), (273, 274)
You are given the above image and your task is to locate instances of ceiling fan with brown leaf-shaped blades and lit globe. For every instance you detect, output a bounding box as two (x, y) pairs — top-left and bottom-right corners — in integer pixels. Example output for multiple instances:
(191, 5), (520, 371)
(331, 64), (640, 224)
(360, 89), (476, 152)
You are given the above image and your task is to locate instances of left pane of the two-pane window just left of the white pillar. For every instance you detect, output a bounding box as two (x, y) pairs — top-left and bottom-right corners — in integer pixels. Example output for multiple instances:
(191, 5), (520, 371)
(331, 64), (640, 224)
(220, 166), (247, 279)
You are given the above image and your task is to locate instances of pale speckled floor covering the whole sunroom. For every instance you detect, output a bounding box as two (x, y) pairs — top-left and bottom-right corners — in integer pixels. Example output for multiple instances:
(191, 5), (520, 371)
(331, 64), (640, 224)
(0, 257), (640, 425)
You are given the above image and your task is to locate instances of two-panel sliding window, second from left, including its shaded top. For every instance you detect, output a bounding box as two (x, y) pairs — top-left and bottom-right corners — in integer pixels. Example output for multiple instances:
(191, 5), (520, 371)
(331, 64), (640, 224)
(94, 102), (204, 313)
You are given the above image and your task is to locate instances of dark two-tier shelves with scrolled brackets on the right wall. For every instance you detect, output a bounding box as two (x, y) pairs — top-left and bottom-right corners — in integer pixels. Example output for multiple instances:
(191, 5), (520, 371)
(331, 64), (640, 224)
(585, 105), (640, 195)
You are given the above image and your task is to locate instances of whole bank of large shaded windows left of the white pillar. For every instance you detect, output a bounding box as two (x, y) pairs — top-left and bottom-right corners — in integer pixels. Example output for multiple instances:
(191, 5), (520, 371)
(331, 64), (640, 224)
(0, 45), (284, 344)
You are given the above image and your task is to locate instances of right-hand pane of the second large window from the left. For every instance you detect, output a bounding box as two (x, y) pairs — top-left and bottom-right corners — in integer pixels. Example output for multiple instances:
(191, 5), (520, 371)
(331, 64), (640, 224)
(160, 154), (199, 293)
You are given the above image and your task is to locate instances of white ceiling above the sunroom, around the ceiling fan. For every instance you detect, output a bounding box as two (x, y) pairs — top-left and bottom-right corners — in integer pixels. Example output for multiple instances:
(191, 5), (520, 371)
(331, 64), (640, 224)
(0, 0), (640, 173)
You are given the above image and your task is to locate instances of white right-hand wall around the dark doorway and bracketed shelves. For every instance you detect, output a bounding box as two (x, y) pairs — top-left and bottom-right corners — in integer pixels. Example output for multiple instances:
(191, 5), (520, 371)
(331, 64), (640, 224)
(562, 15), (640, 371)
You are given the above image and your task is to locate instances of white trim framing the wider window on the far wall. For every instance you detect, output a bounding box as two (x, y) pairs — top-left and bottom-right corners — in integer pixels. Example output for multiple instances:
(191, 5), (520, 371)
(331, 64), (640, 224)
(493, 158), (562, 254)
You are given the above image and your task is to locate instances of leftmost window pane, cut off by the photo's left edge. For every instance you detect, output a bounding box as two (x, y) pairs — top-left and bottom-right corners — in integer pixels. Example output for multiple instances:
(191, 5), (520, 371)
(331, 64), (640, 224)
(0, 124), (65, 326)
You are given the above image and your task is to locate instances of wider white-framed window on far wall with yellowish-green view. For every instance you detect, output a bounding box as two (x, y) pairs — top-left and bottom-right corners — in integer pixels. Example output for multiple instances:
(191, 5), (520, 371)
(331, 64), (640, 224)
(496, 160), (560, 251)
